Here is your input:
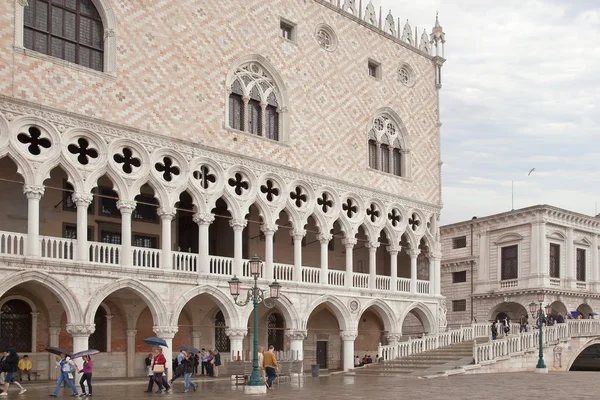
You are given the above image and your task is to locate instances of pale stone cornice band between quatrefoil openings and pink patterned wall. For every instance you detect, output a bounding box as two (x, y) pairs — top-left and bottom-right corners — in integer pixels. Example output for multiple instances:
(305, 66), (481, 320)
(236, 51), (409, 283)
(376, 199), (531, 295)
(0, 95), (441, 214)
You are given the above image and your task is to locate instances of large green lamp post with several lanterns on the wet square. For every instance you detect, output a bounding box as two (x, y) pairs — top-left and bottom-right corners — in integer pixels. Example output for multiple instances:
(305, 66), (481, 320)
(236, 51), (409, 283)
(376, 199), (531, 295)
(228, 256), (281, 394)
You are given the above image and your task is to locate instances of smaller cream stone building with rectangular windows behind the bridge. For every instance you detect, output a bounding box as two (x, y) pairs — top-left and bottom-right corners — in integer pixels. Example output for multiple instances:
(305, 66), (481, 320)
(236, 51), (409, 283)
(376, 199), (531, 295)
(440, 205), (600, 325)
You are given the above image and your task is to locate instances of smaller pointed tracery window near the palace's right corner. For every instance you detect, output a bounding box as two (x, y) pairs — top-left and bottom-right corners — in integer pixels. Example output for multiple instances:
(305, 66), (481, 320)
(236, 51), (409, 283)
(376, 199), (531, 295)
(368, 113), (410, 177)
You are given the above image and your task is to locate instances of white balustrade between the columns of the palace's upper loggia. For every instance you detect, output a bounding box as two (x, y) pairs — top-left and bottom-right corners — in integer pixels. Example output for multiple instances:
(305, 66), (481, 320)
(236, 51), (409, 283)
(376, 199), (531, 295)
(0, 231), (440, 294)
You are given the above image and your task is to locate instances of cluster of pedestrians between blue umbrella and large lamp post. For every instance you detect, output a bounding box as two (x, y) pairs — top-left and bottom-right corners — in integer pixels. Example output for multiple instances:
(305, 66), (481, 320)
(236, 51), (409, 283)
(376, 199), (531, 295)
(144, 346), (221, 393)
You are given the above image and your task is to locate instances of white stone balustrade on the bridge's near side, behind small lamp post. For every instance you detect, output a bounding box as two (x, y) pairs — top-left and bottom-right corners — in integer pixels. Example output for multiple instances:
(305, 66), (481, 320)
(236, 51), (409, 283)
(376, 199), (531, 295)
(473, 319), (600, 364)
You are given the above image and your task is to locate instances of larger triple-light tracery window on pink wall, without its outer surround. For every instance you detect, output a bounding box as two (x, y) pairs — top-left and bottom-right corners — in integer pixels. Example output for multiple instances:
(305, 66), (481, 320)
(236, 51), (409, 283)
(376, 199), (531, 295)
(227, 61), (284, 141)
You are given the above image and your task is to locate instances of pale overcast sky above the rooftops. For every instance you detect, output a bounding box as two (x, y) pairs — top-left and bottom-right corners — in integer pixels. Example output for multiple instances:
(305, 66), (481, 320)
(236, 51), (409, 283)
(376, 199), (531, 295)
(376, 0), (600, 224)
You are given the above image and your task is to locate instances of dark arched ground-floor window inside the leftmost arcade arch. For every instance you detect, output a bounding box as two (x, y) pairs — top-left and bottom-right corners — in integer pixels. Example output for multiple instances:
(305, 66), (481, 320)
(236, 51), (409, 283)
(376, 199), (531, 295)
(0, 300), (32, 353)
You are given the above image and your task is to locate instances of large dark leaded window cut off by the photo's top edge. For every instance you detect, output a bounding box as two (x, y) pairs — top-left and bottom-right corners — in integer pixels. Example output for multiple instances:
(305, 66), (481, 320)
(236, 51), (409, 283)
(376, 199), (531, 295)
(23, 0), (104, 71)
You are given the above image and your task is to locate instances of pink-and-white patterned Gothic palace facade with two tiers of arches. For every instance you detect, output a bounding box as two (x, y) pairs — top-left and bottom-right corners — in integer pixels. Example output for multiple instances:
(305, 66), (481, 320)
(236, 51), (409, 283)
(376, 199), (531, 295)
(0, 0), (446, 377)
